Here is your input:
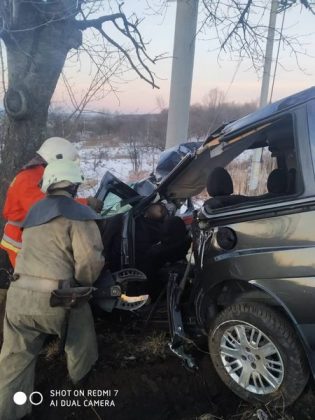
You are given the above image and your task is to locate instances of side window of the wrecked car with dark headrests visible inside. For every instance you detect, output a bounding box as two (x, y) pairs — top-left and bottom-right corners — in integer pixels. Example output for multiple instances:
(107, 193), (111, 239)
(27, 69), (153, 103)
(204, 115), (302, 211)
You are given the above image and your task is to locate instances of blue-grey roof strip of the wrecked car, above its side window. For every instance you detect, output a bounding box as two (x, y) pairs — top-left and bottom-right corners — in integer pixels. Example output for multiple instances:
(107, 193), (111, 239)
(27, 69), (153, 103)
(205, 86), (315, 144)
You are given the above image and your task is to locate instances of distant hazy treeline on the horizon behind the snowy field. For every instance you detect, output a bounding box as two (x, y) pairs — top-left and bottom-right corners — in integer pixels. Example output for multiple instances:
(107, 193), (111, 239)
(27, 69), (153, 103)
(48, 89), (257, 150)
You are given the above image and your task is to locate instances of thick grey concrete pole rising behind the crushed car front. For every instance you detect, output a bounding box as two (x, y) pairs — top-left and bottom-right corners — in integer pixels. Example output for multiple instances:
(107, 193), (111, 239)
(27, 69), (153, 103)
(166, 0), (198, 148)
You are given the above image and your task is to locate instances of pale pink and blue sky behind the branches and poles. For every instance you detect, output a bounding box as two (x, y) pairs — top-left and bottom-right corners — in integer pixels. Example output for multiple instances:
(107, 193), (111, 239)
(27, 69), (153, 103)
(53, 0), (315, 113)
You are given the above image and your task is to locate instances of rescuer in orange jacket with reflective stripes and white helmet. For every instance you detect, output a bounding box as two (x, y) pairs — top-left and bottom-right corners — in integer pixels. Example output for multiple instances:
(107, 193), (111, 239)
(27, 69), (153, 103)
(0, 137), (102, 267)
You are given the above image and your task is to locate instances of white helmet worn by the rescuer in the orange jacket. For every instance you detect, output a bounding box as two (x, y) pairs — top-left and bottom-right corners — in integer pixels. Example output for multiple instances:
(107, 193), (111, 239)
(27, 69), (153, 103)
(37, 137), (80, 163)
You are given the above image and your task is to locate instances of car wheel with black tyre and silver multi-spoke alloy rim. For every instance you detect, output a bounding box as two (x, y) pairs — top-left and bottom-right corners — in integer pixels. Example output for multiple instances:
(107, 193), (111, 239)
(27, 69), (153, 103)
(208, 303), (309, 406)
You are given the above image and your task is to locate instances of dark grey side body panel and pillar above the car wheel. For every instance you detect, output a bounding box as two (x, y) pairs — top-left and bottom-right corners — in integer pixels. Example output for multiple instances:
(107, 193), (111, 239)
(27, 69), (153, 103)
(199, 105), (315, 348)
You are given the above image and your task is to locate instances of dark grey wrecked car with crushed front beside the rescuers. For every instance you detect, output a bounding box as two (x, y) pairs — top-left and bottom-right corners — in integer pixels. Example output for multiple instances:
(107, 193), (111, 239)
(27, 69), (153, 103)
(97, 88), (315, 405)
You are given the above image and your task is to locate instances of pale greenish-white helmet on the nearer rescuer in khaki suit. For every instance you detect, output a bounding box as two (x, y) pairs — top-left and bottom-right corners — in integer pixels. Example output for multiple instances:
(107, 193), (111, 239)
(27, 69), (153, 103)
(41, 159), (84, 193)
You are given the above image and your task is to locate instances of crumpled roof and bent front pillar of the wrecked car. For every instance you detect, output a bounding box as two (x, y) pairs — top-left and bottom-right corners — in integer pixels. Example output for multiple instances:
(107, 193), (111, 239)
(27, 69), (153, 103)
(157, 87), (315, 198)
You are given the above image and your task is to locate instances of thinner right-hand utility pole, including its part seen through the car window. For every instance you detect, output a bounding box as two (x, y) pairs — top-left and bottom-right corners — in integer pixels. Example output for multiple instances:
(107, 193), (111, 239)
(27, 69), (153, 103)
(249, 0), (278, 192)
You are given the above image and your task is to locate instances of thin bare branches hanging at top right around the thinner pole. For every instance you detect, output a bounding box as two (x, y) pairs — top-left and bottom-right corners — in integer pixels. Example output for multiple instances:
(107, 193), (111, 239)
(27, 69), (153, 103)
(199, 0), (314, 72)
